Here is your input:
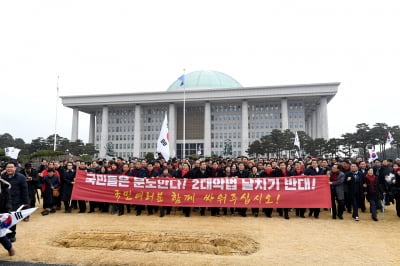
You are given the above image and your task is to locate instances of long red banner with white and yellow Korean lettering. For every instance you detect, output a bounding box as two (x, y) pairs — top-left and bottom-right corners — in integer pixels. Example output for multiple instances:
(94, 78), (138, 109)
(71, 171), (331, 208)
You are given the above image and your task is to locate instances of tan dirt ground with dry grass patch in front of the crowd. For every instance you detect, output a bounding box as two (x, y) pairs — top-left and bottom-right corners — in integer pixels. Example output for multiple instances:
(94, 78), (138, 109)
(0, 205), (400, 265)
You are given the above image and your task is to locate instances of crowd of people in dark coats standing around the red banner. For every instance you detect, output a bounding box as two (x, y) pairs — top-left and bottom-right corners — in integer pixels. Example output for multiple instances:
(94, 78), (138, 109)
(0, 157), (400, 255)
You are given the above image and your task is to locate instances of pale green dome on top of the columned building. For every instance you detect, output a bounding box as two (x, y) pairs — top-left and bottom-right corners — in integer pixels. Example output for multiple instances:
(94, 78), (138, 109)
(167, 70), (243, 91)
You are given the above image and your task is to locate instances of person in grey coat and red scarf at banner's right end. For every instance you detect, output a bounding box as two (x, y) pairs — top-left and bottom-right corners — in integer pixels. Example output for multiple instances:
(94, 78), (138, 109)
(328, 164), (346, 220)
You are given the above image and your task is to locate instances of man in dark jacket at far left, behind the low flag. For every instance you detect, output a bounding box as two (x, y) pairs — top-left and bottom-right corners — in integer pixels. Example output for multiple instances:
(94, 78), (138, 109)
(1, 162), (29, 242)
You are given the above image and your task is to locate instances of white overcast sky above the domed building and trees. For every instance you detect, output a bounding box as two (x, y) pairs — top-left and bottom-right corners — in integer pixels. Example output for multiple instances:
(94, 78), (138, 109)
(0, 0), (400, 145)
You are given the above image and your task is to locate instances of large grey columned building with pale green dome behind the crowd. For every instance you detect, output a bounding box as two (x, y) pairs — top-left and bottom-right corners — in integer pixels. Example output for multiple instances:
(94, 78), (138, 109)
(61, 70), (340, 158)
